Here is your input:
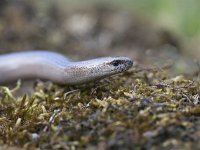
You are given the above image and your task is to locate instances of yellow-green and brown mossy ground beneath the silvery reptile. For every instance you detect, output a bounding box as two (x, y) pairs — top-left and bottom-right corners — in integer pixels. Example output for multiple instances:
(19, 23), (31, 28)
(0, 67), (200, 149)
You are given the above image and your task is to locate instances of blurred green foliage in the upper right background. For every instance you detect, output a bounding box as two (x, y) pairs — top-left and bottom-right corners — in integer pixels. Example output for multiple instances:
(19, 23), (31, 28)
(58, 0), (200, 37)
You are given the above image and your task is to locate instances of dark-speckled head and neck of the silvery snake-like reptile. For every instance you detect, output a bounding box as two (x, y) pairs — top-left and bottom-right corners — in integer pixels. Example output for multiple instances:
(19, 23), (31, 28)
(67, 57), (133, 84)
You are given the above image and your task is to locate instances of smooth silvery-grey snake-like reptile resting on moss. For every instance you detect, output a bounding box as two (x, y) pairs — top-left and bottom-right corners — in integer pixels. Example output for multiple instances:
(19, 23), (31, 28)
(0, 51), (133, 85)
